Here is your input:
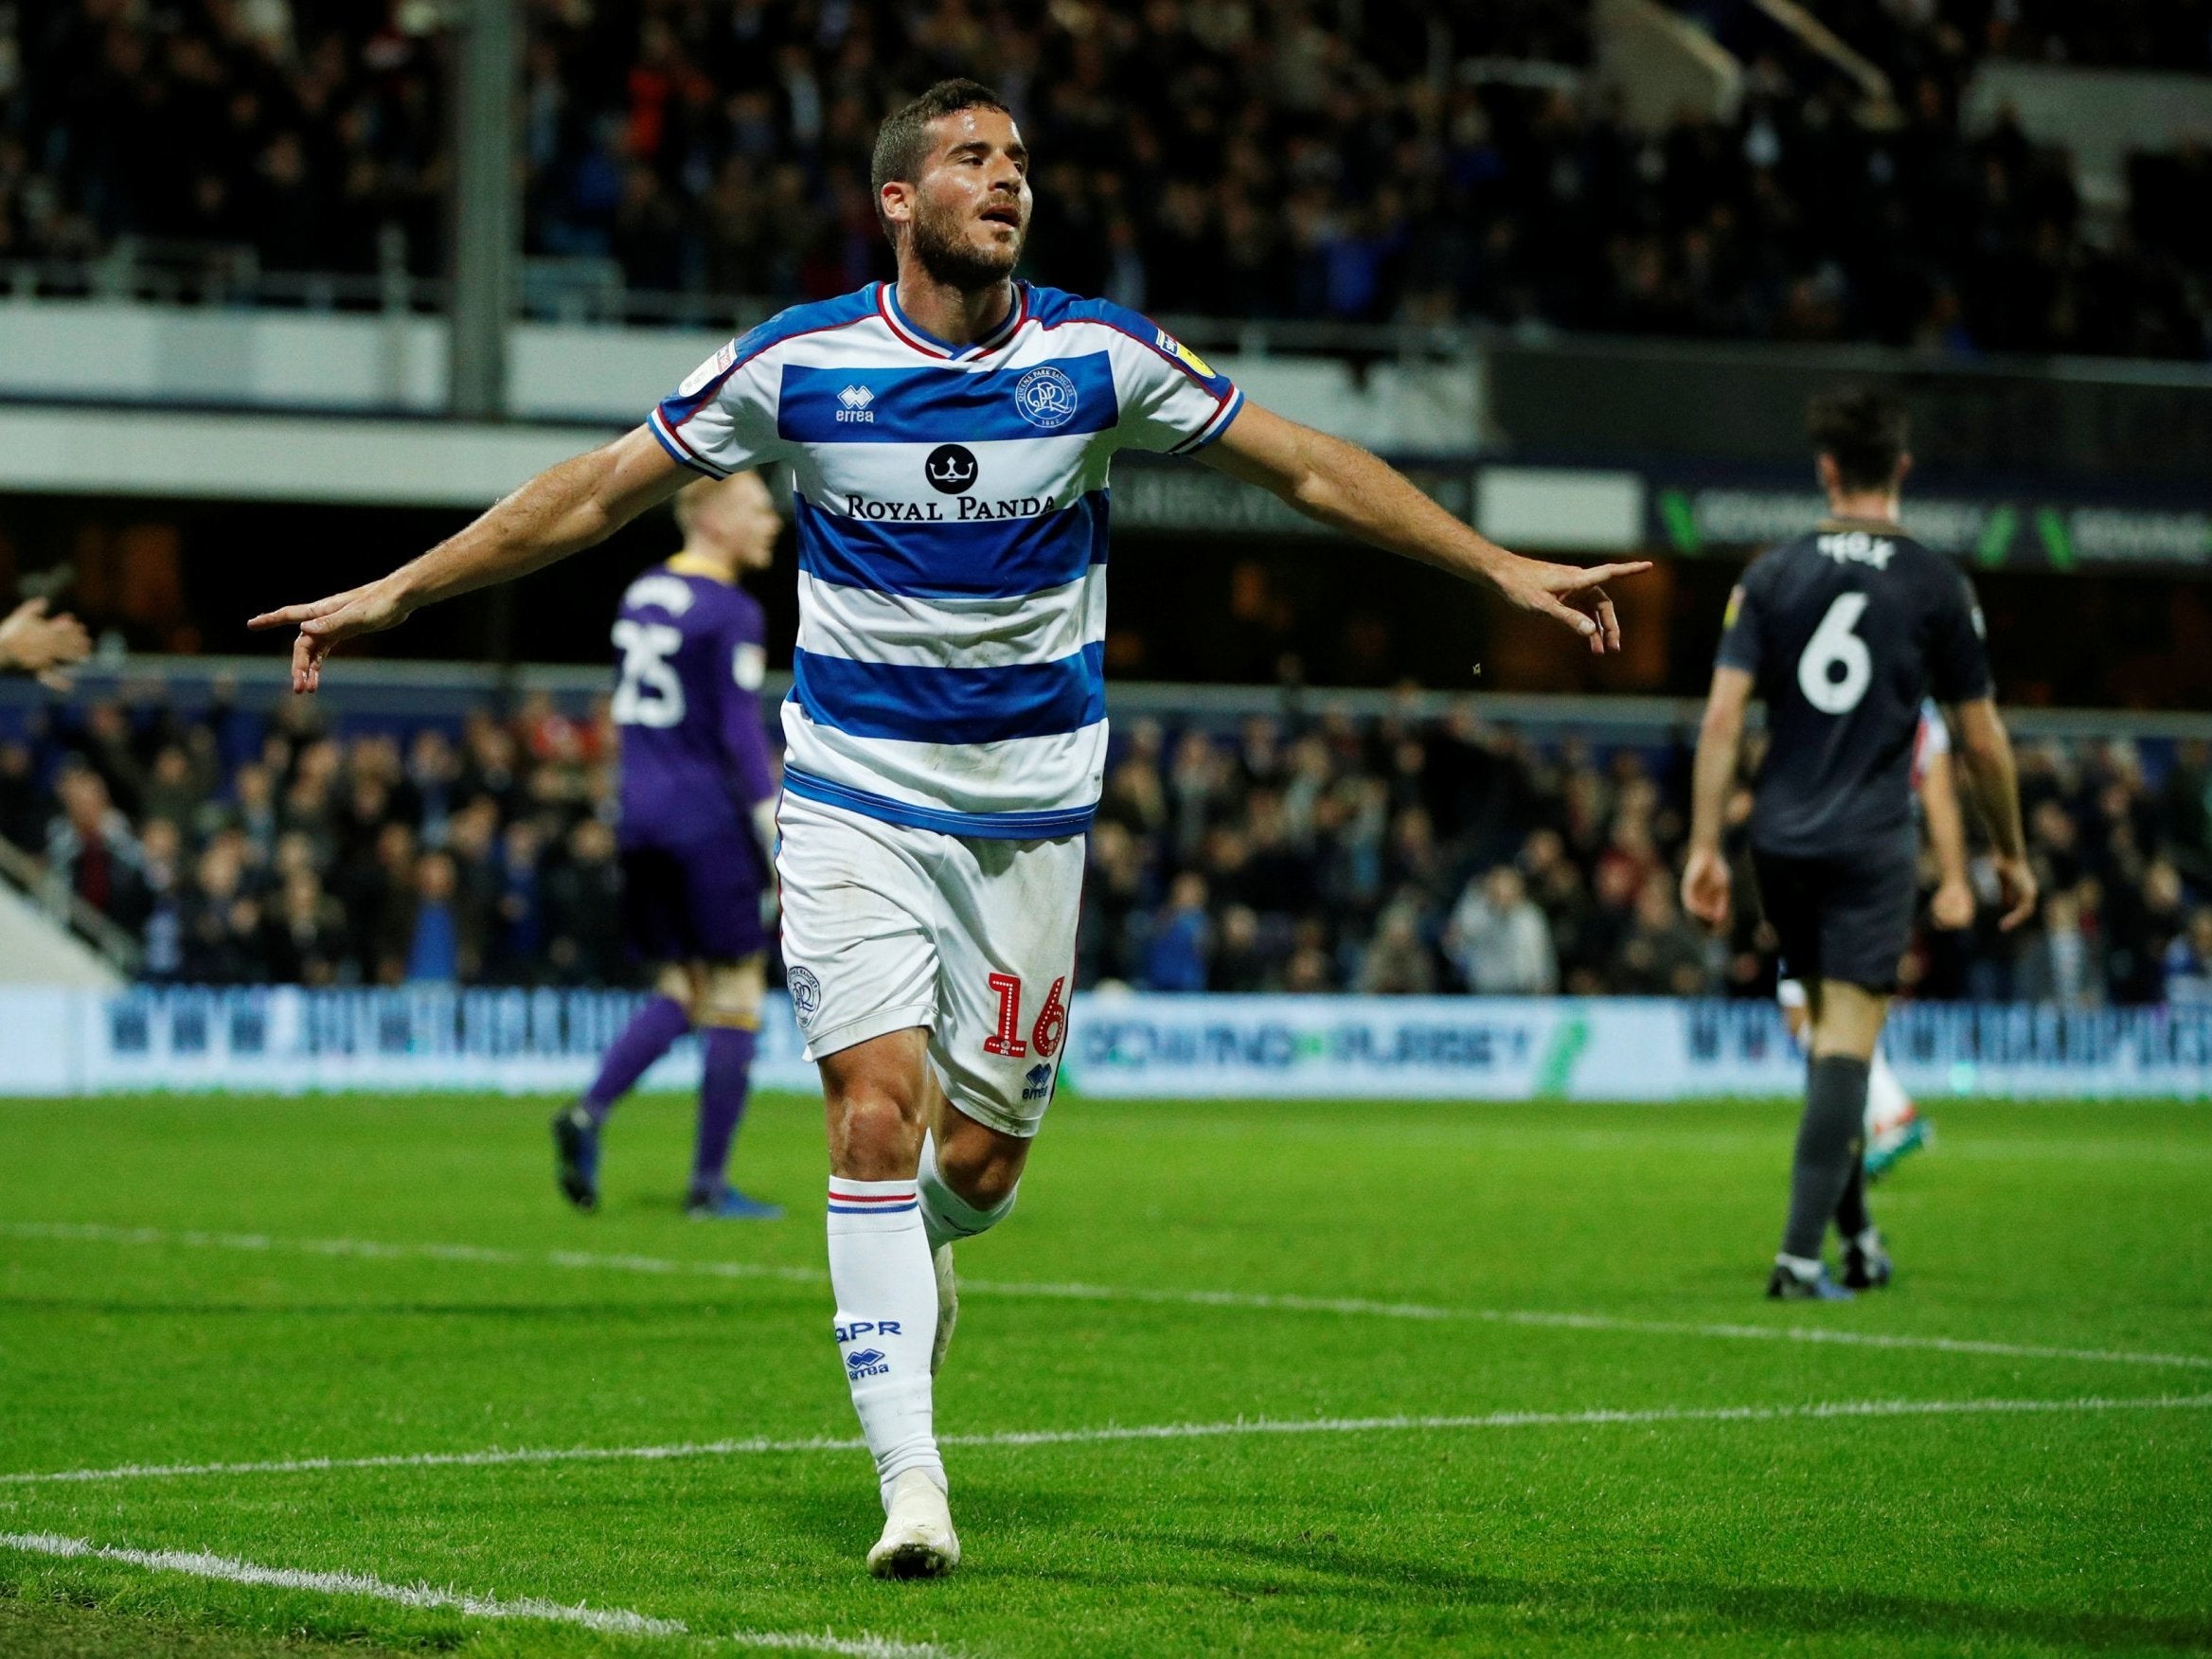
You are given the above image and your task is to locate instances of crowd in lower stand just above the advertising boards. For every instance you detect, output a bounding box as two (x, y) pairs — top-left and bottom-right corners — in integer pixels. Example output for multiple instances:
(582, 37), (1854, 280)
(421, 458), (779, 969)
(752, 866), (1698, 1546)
(0, 695), (2212, 1007)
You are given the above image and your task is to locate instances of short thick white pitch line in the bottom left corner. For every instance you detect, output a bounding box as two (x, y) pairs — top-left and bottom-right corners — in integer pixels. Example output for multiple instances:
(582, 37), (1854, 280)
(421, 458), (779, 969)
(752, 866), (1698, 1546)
(0, 1533), (947, 1659)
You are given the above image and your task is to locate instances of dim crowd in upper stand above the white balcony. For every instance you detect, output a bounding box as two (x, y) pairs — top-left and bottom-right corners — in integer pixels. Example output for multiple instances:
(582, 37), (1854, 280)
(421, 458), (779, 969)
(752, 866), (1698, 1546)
(0, 0), (2212, 358)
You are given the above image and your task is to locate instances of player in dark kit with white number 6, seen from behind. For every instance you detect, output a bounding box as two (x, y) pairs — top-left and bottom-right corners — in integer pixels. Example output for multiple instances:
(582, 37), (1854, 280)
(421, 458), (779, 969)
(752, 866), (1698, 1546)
(1681, 389), (2035, 1301)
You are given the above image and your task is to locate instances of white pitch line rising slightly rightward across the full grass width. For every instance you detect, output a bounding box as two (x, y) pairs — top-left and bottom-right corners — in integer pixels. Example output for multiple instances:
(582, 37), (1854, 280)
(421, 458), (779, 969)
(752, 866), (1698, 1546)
(0, 1394), (2212, 1487)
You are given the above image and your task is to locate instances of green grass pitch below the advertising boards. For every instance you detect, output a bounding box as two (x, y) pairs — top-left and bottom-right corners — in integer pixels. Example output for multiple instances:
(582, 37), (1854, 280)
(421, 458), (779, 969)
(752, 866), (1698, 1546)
(0, 1097), (2212, 1659)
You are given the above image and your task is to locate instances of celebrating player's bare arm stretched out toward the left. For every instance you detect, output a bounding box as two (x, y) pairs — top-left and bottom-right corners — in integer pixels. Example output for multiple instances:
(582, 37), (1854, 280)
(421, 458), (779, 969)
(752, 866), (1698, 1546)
(245, 427), (690, 692)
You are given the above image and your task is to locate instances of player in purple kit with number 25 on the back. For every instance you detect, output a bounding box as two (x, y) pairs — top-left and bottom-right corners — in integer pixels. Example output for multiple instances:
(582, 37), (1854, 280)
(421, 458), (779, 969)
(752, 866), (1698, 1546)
(553, 473), (783, 1221)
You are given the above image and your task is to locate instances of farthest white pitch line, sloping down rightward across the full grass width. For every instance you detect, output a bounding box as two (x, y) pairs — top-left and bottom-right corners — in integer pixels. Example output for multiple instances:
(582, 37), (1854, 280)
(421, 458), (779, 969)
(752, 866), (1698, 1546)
(0, 1221), (2212, 1369)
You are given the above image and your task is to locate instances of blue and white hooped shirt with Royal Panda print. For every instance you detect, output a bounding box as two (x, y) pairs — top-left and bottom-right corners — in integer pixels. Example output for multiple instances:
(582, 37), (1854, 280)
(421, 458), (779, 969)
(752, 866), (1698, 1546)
(652, 283), (1243, 841)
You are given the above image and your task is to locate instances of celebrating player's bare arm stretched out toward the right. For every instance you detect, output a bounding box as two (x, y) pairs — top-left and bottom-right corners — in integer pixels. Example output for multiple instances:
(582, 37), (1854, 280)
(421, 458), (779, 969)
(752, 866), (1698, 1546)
(1199, 402), (1650, 657)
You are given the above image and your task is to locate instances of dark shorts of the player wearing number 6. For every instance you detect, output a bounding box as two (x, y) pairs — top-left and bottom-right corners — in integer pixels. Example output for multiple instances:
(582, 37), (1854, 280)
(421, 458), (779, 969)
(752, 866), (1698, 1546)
(1752, 841), (1920, 995)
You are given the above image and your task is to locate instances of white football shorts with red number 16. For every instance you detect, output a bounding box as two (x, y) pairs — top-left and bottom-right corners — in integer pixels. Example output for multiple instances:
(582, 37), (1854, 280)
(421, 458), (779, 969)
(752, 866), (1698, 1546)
(776, 794), (1084, 1137)
